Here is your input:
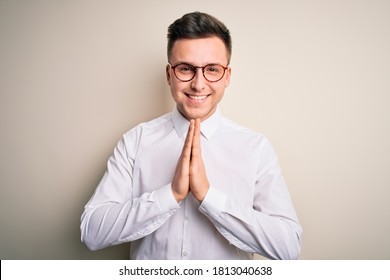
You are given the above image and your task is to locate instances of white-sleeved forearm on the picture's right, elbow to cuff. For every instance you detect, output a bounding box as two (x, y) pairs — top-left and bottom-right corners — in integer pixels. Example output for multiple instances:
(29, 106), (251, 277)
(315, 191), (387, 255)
(199, 188), (301, 259)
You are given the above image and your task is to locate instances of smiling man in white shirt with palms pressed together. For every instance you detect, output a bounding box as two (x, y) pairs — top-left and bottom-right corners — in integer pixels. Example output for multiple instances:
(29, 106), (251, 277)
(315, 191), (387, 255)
(81, 12), (301, 259)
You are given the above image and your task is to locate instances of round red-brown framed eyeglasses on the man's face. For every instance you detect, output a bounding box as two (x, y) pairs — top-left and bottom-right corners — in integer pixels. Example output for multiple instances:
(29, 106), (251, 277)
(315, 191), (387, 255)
(169, 63), (228, 83)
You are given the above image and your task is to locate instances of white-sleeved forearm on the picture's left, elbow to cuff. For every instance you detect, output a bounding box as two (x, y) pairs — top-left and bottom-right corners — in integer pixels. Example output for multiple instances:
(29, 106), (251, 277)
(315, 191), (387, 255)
(81, 185), (179, 250)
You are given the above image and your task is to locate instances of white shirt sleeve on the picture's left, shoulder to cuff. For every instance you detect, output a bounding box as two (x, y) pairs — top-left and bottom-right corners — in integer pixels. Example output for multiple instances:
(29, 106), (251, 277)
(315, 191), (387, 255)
(80, 133), (180, 250)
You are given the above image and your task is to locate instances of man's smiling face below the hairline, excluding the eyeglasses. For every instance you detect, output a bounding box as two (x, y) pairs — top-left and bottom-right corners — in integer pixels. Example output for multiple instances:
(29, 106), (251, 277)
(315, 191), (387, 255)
(166, 37), (231, 121)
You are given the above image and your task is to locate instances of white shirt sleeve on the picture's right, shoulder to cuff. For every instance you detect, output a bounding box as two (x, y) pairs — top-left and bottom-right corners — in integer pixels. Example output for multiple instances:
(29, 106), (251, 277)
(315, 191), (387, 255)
(199, 138), (302, 259)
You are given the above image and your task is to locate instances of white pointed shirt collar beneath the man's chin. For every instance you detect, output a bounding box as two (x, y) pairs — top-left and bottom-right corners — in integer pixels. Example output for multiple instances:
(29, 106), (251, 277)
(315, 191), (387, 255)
(172, 106), (222, 140)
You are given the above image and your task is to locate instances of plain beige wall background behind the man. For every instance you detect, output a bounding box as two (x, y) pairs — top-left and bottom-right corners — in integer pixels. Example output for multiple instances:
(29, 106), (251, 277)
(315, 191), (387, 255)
(0, 0), (390, 259)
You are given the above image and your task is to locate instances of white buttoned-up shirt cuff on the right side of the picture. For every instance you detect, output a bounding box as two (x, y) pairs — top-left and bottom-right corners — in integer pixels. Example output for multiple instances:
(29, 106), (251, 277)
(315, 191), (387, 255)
(199, 186), (227, 218)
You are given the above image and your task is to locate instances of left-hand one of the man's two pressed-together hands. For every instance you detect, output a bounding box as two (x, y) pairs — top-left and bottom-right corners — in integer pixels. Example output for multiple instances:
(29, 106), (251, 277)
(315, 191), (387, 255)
(172, 120), (195, 202)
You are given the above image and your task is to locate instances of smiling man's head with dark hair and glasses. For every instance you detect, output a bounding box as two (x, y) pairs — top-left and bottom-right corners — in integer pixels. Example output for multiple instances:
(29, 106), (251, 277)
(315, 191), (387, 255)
(166, 12), (231, 120)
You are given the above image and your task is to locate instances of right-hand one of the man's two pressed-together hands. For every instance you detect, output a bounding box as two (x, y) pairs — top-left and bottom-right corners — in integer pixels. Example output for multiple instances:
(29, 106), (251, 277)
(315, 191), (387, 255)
(190, 119), (210, 202)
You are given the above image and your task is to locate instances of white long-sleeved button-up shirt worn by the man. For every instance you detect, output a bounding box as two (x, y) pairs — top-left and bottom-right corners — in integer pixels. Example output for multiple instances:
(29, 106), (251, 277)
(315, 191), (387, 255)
(81, 108), (302, 259)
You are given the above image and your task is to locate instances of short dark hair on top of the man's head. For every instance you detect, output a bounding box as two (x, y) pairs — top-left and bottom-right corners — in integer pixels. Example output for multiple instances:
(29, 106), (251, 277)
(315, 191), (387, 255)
(168, 12), (232, 63)
